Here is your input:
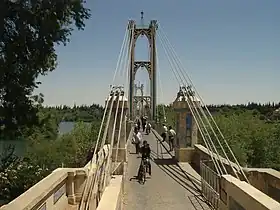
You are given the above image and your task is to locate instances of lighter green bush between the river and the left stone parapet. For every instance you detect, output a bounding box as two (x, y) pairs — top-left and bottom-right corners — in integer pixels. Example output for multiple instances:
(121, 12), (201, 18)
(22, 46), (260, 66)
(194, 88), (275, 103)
(27, 122), (98, 169)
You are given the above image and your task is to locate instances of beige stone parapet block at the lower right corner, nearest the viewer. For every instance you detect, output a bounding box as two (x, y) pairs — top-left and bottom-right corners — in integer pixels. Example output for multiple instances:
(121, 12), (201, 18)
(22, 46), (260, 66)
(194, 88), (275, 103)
(220, 175), (280, 210)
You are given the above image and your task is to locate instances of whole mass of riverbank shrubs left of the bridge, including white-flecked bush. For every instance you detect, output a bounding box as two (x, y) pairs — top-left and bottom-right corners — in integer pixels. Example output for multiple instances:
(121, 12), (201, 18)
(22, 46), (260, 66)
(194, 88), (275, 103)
(0, 105), (103, 202)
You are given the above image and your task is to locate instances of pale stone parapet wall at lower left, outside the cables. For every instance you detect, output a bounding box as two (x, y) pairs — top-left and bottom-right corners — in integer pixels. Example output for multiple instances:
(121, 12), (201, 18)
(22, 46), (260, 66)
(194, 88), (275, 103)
(0, 145), (110, 210)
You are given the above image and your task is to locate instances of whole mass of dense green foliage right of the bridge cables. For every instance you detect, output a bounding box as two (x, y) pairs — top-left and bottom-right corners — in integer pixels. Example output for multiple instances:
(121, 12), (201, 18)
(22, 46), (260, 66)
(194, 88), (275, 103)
(208, 109), (280, 169)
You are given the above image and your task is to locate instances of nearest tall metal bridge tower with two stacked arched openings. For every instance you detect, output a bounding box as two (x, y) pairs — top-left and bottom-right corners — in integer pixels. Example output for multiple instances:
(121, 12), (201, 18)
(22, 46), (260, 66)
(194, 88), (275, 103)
(128, 12), (158, 120)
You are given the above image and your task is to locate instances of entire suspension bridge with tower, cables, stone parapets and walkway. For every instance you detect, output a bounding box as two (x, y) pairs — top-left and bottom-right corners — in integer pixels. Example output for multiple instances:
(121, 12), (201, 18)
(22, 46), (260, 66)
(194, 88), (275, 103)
(1, 14), (280, 210)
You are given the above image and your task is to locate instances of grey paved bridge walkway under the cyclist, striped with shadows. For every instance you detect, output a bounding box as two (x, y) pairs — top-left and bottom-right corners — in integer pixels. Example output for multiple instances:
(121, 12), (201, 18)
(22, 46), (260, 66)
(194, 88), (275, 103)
(124, 133), (210, 210)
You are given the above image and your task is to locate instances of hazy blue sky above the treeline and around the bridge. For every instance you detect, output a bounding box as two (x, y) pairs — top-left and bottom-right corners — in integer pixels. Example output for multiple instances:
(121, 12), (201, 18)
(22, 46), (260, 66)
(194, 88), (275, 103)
(36, 0), (280, 105)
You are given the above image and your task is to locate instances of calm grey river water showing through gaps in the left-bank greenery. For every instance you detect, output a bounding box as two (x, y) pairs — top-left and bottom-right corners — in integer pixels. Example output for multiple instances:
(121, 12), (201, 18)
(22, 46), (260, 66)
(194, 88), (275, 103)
(0, 122), (75, 156)
